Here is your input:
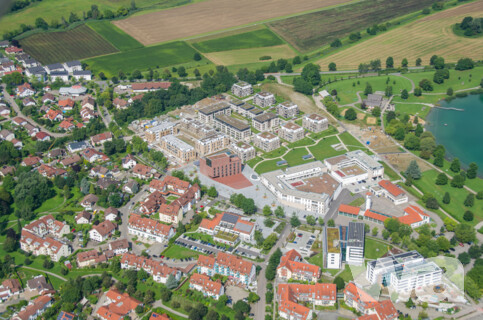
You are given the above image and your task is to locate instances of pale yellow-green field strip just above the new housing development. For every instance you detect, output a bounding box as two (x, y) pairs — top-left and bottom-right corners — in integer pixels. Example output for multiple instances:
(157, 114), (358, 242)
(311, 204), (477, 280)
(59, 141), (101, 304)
(205, 44), (296, 65)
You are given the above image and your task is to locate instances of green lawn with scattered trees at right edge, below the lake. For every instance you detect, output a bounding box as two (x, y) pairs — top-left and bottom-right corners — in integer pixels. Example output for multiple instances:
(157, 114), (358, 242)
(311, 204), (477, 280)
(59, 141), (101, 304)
(414, 170), (483, 225)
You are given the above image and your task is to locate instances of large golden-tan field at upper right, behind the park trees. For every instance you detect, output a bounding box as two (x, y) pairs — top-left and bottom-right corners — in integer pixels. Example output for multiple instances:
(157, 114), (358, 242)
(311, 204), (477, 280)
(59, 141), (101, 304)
(317, 1), (483, 70)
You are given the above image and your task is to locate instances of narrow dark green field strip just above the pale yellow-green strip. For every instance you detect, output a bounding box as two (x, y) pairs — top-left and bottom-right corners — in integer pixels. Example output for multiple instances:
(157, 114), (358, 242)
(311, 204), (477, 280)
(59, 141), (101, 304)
(193, 29), (284, 53)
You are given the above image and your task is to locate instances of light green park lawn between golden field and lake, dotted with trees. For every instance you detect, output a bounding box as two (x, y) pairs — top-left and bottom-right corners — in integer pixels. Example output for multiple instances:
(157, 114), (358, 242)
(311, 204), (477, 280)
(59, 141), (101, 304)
(323, 76), (411, 105)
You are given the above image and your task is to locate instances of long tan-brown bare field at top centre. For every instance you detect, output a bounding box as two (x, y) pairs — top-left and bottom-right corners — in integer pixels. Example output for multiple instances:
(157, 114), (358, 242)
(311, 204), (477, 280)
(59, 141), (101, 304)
(114, 0), (350, 45)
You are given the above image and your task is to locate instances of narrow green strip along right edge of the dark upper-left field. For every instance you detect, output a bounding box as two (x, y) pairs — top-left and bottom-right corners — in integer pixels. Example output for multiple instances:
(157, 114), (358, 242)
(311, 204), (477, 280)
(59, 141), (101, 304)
(87, 21), (143, 51)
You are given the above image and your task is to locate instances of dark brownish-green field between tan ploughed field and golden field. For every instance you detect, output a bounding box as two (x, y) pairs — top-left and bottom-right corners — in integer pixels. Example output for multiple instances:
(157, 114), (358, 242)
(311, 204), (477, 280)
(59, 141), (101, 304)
(268, 0), (434, 52)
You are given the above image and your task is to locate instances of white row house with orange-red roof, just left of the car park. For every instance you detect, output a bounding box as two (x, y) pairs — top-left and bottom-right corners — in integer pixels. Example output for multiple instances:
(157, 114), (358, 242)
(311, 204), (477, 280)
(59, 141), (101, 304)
(128, 213), (176, 242)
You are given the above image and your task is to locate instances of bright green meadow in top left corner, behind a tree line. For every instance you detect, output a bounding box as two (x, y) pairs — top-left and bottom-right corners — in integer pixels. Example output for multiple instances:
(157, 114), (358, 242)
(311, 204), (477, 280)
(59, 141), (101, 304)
(0, 0), (202, 34)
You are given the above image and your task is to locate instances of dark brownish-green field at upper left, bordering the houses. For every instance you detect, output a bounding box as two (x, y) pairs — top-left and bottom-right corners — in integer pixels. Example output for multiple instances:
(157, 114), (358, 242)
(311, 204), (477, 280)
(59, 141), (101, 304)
(20, 25), (118, 64)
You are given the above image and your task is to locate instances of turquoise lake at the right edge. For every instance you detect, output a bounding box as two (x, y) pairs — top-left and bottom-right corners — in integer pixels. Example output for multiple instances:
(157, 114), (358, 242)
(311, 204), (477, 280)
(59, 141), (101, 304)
(426, 94), (483, 176)
